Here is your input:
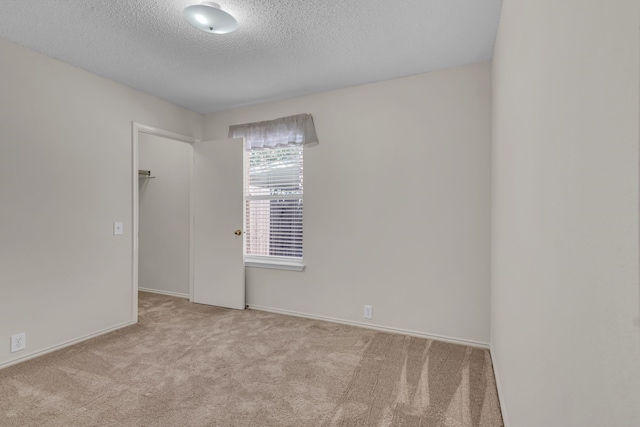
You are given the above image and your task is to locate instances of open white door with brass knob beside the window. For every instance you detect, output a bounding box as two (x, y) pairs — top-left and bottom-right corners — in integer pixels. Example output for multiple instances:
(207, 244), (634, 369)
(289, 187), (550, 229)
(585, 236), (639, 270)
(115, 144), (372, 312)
(193, 139), (245, 310)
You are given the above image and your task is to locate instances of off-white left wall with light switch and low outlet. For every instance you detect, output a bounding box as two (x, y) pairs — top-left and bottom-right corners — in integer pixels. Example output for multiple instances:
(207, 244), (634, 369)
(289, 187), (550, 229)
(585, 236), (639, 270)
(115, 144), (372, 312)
(0, 40), (202, 365)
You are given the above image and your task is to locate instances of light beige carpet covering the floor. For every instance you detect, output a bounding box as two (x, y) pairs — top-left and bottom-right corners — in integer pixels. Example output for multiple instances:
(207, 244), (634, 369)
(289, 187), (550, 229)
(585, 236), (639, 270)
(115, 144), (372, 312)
(0, 292), (503, 427)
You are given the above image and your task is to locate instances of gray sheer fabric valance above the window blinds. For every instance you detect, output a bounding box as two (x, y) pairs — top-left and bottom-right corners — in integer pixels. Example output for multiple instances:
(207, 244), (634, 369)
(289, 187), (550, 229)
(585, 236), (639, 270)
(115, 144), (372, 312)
(229, 114), (318, 151)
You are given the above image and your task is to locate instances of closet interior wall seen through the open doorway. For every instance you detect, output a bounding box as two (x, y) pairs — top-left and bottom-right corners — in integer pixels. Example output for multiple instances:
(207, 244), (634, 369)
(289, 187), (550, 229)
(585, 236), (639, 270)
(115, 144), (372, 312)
(138, 133), (191, 296)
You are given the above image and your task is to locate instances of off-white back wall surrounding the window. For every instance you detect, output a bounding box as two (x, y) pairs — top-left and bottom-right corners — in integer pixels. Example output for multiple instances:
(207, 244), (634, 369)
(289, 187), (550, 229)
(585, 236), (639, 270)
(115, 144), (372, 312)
(204, 63), (491, 343)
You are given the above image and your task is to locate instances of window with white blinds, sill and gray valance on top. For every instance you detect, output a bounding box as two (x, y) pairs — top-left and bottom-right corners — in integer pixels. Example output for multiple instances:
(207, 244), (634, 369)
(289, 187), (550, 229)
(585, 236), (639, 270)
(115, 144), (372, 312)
(229, 114), (318, 270)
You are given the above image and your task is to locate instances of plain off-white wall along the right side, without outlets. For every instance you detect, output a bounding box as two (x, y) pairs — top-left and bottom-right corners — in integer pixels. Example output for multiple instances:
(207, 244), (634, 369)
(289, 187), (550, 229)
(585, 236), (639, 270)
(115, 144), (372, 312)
(491, 0), (640, 427)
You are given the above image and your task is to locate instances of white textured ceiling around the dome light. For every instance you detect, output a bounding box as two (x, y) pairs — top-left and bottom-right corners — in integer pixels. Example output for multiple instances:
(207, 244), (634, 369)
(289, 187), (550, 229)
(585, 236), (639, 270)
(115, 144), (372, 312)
(0, 0), (502, 113)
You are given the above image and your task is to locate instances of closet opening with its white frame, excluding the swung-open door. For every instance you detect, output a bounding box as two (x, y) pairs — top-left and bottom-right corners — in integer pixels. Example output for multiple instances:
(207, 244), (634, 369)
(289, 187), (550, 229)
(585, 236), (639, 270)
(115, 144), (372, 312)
(131, 122), (198, 319)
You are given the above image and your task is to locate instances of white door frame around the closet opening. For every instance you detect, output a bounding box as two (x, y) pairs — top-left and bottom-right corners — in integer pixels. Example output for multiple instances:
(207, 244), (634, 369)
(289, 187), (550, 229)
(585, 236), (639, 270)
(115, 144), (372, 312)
(131, 122), (201, 322)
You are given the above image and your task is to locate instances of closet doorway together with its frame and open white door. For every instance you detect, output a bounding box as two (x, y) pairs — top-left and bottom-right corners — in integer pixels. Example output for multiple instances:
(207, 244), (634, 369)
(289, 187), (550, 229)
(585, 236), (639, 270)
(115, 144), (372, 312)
(131, 122), (245, 319)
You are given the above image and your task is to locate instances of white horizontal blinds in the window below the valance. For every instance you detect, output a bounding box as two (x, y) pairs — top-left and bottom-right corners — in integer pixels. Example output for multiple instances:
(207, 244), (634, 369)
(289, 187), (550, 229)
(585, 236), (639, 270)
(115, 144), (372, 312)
(245, 145), (303, 259)
